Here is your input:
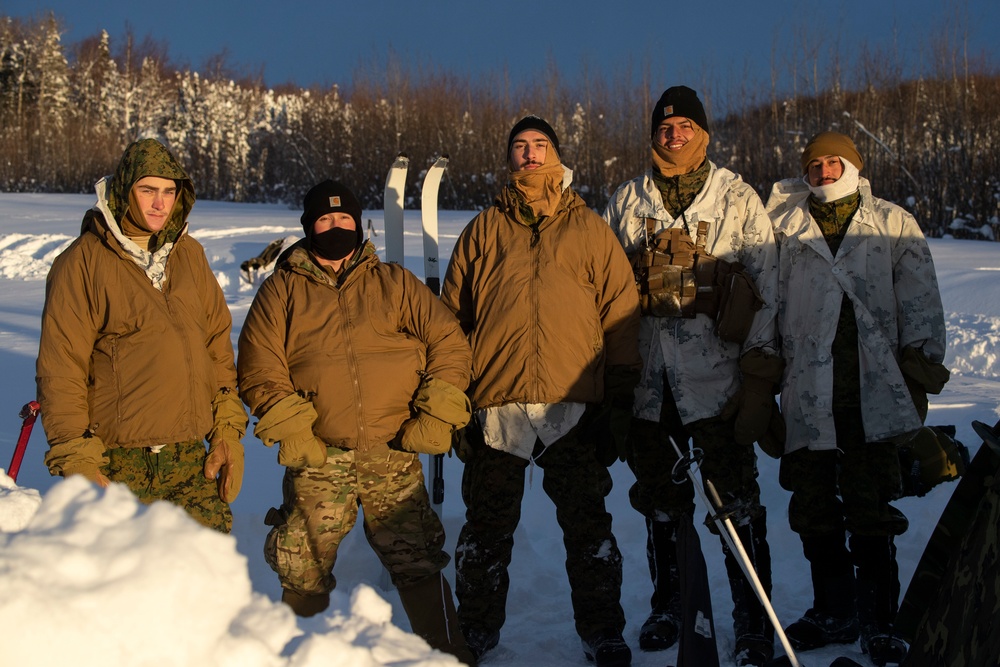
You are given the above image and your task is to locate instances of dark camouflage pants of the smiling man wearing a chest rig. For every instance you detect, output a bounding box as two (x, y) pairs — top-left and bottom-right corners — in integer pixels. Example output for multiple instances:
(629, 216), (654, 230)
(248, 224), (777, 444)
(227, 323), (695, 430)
(628, 394), (765, 533)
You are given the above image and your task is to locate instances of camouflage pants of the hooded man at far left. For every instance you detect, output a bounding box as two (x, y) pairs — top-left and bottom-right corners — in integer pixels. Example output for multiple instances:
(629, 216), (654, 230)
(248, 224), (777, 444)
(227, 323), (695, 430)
(101, 440), (233, 533)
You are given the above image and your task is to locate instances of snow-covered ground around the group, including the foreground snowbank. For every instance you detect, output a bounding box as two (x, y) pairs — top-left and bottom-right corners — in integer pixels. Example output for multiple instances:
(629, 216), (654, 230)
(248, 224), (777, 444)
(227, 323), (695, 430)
(0, 190), (1000, 667)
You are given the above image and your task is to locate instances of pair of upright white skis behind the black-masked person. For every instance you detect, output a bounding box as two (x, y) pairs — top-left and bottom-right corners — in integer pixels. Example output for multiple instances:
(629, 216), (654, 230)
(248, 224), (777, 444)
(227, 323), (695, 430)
(383, 153), (448, 508)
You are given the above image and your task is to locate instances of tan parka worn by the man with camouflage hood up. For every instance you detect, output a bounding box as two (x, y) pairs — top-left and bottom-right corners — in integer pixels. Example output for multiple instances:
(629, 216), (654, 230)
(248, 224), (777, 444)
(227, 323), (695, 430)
(36, 180), (236, 447)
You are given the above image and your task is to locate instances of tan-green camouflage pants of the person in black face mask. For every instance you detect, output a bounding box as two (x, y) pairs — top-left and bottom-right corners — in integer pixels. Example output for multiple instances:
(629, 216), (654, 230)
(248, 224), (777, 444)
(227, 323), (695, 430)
(264, 445), (450, 595)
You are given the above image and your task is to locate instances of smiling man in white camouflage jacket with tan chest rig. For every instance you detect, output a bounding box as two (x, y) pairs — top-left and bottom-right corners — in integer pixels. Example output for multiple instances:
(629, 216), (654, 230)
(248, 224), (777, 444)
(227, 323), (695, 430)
(604, 86), (781, 665)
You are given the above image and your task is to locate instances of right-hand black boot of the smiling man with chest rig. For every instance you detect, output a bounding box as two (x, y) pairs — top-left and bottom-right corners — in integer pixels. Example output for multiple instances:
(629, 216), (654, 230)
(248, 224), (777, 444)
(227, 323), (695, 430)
(723, 514), (774, 667)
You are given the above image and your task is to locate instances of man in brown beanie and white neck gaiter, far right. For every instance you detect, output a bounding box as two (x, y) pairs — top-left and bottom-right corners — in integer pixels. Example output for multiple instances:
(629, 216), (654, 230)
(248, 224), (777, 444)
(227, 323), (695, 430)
(767, 132), (948, 665)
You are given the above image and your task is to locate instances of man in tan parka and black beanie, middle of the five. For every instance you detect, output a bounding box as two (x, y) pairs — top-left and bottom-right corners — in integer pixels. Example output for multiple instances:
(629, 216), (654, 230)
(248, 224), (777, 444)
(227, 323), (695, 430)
(441, 116), (641, 667)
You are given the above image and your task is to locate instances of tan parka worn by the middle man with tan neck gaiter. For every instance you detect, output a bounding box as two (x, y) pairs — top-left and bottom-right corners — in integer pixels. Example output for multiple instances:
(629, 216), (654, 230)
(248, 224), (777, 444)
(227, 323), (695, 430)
(441, 188), (641, 408)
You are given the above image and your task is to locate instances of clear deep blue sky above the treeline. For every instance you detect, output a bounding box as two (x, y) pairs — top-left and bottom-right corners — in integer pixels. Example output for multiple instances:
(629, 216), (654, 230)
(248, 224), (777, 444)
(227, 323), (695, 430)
(0, 0), (1000, 107)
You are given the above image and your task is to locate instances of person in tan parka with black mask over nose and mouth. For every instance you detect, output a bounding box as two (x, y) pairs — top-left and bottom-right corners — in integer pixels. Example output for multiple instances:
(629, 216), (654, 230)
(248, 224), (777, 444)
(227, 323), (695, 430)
(239, 180), (475, 664)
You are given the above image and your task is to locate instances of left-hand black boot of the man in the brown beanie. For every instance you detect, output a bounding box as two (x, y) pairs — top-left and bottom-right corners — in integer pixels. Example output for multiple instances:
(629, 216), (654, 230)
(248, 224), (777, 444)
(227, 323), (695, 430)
(785, 532), (858, 651)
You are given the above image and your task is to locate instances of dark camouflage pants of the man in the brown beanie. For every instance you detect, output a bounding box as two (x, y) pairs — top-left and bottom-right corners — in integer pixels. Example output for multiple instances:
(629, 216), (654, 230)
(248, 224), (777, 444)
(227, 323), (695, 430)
(778, 410), (909, 536)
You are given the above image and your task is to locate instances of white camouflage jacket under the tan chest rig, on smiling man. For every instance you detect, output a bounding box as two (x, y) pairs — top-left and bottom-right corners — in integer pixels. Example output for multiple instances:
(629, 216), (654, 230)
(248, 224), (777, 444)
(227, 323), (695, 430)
(604, 163), (778, 424)
